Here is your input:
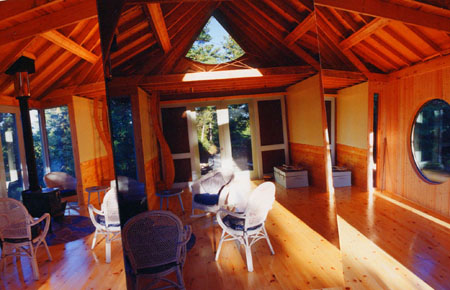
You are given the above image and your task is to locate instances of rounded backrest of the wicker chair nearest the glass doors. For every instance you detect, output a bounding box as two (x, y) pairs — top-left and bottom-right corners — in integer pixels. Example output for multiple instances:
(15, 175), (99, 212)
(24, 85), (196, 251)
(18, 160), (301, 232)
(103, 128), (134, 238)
(191, 169), (234, 194)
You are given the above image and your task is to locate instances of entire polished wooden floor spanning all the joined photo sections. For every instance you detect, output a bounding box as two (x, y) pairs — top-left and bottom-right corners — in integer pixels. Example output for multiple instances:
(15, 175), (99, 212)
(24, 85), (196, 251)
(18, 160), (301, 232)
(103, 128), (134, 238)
(0, 182), (450, 289)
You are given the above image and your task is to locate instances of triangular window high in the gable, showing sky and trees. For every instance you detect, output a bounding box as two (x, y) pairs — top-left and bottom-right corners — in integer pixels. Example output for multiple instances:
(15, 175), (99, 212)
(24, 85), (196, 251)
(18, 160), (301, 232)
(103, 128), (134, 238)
(186, 16), (245, 64)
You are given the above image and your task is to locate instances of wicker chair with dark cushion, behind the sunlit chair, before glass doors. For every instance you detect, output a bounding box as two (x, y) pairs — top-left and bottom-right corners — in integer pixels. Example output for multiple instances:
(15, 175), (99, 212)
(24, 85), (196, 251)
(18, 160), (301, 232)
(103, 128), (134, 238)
(191, 169), (234, 217)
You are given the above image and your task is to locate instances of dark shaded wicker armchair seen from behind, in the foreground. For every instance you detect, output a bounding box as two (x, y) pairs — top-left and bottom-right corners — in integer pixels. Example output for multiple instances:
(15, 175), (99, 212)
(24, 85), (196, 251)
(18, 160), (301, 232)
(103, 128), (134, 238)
(122, 210), (192, 289)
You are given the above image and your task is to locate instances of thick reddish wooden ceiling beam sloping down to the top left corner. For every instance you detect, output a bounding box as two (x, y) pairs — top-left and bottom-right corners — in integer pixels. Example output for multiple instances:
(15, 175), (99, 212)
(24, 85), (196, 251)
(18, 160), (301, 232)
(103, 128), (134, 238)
(0, 0), (97, 46)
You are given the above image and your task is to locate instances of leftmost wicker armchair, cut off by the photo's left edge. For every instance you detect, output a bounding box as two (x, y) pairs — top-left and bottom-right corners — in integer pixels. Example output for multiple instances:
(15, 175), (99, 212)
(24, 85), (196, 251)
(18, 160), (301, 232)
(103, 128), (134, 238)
(0, 198), (52, 280)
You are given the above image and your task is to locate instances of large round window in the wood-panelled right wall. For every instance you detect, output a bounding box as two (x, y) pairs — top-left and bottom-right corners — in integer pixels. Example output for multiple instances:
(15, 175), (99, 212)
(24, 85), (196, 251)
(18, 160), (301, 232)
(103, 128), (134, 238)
(411, 99), (450, 183)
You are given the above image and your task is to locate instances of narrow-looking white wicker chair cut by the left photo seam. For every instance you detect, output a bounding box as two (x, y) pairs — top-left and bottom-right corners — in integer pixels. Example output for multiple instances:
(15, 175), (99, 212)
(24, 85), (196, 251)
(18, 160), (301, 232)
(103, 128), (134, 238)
(88, 183), (120, 263)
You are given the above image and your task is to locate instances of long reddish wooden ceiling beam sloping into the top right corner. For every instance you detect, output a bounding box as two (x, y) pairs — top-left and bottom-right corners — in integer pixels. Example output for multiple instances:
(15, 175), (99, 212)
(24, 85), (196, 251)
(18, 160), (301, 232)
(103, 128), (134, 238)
(314, 0), (450, 33)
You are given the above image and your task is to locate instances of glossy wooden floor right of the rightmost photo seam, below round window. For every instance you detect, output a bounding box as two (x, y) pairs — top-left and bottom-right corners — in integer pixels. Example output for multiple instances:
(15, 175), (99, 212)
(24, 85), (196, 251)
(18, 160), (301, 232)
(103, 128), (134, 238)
(336, 187), (450, 289)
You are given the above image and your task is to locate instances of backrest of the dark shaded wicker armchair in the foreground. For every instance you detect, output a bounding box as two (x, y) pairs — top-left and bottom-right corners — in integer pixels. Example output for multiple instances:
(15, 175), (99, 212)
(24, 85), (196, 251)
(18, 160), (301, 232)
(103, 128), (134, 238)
(122, 210), (184, 273)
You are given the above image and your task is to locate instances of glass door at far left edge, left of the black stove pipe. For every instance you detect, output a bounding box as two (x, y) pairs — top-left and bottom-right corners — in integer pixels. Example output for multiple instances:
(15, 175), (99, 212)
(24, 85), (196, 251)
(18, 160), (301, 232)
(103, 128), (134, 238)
(0, 107), (26, 200)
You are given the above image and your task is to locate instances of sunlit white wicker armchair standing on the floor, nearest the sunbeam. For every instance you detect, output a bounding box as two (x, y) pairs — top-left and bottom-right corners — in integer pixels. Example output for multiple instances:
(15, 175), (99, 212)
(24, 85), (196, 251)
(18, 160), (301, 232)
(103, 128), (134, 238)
(216, 182), (275, 272)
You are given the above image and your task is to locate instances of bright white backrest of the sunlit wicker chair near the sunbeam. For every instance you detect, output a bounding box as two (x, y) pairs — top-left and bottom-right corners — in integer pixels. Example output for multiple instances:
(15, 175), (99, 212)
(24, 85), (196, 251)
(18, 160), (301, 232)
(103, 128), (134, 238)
(245, 182), (275, 228)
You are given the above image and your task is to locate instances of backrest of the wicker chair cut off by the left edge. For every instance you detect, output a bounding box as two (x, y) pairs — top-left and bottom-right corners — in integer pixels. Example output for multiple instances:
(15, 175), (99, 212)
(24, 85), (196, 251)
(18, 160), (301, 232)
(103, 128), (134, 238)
(0, 198), (32, 241)
